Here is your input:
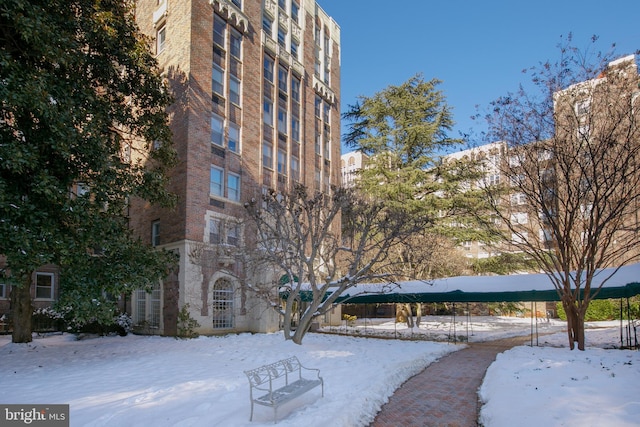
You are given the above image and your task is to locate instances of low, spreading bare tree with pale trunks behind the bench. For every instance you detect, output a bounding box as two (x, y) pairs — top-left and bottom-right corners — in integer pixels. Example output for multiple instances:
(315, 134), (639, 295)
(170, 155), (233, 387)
(246, 184), (430, 344)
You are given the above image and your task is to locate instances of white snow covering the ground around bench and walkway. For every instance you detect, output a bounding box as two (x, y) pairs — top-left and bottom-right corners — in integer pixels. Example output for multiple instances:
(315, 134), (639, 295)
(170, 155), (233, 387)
(0, 317), (640, 427)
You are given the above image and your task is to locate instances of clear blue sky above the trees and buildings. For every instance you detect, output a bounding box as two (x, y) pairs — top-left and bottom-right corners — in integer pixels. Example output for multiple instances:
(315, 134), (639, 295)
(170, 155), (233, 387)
(318, 0), (640, 149)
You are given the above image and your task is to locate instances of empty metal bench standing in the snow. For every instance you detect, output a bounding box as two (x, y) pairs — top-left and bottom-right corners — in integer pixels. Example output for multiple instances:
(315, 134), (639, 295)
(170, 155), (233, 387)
(244, 356), (324, 423)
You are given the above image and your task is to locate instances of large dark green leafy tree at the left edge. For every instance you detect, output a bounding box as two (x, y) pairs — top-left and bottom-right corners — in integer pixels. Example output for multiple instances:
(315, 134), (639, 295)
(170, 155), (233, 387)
(0, 0), (175, 342)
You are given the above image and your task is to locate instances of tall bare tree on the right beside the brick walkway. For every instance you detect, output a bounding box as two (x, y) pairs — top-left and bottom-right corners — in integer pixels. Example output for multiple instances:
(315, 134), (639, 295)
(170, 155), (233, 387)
(485, 39), (640, 350)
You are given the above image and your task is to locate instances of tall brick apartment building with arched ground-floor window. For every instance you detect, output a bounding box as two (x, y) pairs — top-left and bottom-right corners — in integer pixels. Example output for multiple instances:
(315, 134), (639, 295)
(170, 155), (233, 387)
(130, 0), (340, 334)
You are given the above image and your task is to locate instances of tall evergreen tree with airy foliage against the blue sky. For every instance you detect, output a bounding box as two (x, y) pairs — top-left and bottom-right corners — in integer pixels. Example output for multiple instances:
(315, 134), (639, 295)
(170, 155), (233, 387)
(344, 75), (489, 279)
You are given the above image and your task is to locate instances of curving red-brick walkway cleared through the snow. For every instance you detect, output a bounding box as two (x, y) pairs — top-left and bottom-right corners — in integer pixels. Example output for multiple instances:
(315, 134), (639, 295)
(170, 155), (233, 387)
(369, 336), (530, 427)
